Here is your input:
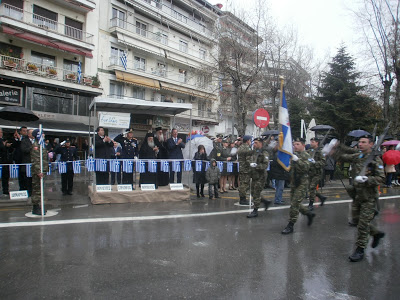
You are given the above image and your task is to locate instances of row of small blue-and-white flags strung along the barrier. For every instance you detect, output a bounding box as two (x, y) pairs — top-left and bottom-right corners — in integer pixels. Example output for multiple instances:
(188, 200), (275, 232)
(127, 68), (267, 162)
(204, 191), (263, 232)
(0, 158), (239, 178)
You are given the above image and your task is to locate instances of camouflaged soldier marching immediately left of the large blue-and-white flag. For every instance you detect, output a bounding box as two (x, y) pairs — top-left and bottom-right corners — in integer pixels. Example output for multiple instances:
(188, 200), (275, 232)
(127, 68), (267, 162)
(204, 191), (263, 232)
(245, 138), (271, 218)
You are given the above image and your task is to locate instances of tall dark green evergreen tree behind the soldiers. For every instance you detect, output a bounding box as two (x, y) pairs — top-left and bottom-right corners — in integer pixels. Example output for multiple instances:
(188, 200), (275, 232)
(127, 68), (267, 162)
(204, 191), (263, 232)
(314, 46), (381, 141)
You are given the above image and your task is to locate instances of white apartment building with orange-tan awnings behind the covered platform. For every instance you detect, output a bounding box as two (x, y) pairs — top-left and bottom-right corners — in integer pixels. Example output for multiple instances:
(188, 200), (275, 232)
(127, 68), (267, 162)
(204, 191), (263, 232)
(97, 0), (220, 137)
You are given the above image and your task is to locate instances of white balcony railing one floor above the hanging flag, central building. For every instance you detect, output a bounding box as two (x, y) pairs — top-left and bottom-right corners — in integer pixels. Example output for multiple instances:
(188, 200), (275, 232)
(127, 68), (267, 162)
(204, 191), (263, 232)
(110, 18), (208, 61)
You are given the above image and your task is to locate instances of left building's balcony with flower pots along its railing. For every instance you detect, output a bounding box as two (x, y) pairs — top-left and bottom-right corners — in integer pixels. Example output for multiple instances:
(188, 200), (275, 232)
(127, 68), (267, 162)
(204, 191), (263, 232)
(0, 55), (98, 87)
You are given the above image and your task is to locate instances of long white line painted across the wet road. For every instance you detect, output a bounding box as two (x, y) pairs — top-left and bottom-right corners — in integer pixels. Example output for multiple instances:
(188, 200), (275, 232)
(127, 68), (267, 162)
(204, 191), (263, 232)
(0, 195), (400, 228)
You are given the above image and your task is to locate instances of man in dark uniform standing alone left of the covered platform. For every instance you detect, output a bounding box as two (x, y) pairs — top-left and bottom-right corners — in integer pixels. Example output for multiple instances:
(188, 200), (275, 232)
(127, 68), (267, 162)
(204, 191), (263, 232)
(56, 140), (79, 195)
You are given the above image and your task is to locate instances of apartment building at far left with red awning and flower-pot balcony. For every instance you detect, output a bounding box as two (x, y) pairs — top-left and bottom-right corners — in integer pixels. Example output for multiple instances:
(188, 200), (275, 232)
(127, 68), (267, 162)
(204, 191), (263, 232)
(0, 0), (103, 136)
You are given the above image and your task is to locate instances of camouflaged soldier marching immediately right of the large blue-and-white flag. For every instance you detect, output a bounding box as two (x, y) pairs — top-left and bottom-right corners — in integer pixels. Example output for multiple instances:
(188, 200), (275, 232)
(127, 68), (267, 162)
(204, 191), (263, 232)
(282, 138), (315, 234)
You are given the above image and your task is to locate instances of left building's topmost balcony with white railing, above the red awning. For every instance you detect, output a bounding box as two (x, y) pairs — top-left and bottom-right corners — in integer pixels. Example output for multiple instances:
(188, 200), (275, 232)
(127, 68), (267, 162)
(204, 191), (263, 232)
(0, 3), (93, 49)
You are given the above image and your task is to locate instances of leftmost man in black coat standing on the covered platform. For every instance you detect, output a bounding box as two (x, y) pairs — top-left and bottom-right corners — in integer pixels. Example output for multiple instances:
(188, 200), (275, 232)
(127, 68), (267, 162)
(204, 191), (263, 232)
(94, 127), (113, 184)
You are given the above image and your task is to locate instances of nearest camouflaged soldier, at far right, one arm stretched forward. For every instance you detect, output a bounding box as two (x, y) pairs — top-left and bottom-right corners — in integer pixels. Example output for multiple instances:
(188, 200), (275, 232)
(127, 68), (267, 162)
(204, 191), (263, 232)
(334, 136), (385, 262)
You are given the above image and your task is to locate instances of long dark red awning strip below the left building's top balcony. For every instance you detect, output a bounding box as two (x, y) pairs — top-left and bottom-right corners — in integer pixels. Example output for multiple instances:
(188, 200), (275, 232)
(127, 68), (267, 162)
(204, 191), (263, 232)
(2, 26), (93, 58)
